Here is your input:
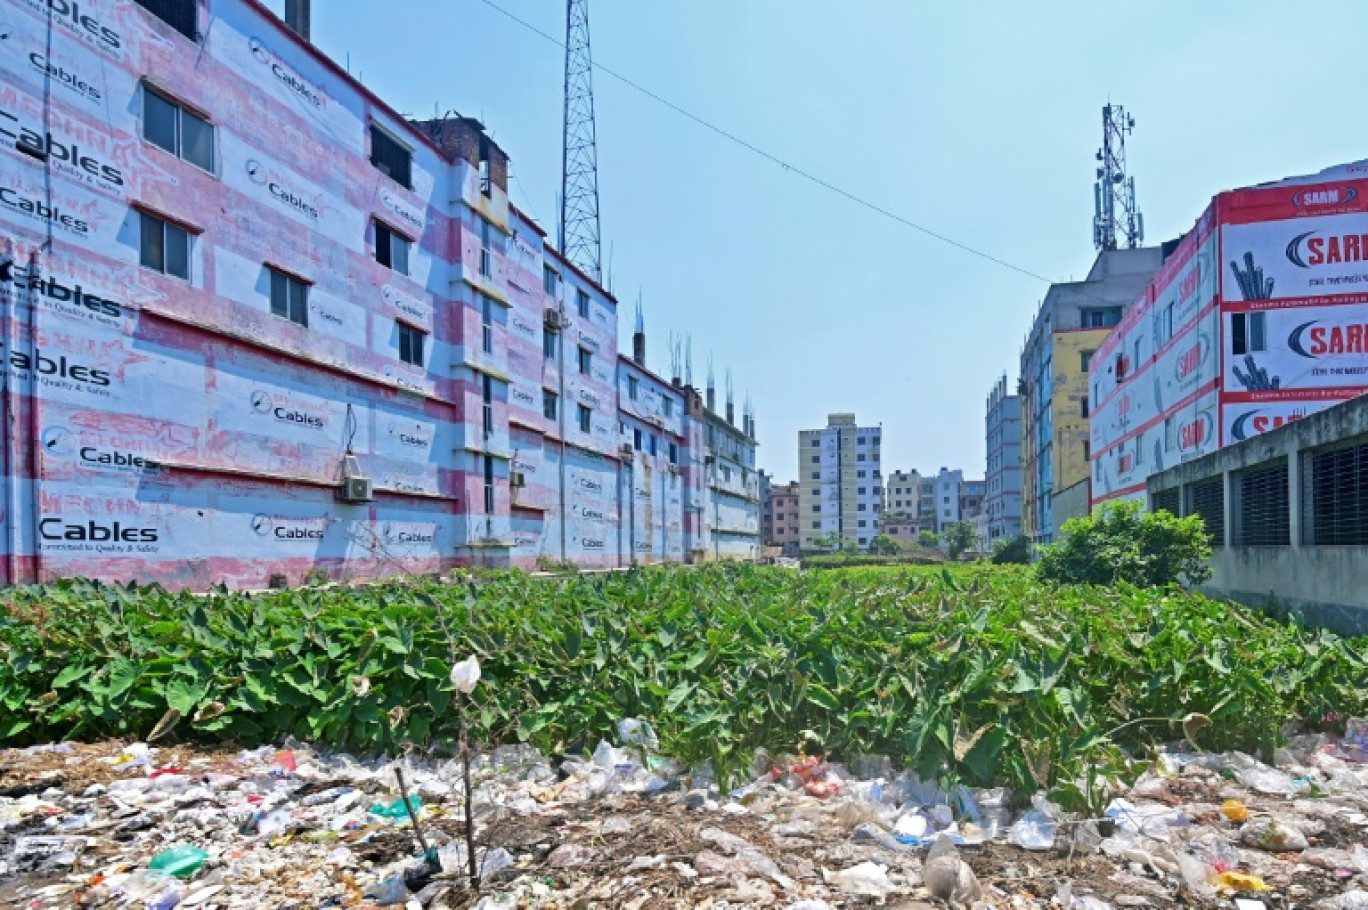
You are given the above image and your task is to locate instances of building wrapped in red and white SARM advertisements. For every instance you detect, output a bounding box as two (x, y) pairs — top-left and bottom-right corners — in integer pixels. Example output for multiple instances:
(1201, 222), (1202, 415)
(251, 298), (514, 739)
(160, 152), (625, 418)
(1090, 163), (1368, 504)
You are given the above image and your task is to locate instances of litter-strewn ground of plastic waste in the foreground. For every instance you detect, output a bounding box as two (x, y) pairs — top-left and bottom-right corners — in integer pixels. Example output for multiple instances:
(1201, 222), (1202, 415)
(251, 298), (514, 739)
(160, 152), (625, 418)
(0, 720), (1368, 910)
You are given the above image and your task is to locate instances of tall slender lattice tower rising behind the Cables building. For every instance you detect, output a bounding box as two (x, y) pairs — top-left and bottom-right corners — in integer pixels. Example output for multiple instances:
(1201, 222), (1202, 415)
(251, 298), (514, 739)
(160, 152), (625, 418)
(561, 0), (603, 282)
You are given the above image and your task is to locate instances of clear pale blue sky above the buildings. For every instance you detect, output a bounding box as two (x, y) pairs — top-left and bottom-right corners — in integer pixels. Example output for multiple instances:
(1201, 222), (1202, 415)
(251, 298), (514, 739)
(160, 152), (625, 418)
(271, 0), (1368, 480)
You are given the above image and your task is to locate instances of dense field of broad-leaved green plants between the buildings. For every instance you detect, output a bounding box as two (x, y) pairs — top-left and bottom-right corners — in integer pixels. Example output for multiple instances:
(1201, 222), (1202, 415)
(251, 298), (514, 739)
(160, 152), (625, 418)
(0, 565), (1368, 802)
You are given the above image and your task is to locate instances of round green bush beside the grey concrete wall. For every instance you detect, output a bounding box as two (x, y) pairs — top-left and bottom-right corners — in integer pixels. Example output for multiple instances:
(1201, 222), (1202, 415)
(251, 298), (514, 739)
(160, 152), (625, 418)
(1037, 502), (1211, 586)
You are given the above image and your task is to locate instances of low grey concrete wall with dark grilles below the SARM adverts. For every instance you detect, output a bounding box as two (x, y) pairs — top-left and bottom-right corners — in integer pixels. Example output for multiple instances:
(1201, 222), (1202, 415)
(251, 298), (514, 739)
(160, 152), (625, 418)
(1148, 395), (1368, 634)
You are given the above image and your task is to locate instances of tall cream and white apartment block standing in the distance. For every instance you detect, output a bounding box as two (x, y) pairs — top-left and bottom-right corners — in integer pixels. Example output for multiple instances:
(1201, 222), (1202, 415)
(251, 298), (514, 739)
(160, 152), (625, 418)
(798, 413), (884, 550)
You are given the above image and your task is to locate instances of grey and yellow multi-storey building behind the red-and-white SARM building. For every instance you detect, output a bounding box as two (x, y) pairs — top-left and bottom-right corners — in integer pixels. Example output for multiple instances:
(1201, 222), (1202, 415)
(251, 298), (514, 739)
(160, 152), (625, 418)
(1018, 248), (1161, 543)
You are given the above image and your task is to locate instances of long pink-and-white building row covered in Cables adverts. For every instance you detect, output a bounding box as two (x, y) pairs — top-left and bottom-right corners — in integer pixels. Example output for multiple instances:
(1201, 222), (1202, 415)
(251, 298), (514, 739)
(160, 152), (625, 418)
(0, 0), (758, 588)
